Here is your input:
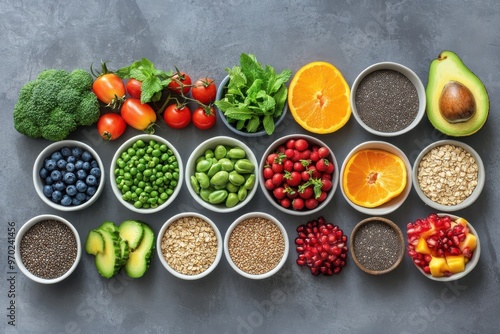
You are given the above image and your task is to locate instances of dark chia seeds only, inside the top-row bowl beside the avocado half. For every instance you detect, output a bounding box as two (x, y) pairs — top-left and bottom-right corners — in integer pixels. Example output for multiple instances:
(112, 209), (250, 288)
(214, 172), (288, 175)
(355, 70), (419, 132)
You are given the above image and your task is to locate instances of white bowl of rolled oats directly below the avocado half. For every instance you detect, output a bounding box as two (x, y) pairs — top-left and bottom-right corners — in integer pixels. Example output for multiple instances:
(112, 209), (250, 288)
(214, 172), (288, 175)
(412, 140), (485, 212)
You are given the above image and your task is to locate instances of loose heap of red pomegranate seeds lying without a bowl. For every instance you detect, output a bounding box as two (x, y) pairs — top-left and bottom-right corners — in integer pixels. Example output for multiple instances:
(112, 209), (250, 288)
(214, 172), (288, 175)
(295, 217), (348, 276)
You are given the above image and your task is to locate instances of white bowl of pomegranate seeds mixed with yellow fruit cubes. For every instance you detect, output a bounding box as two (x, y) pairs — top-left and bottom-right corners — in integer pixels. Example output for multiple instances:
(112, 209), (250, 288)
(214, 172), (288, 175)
(406, 213), (481, 282)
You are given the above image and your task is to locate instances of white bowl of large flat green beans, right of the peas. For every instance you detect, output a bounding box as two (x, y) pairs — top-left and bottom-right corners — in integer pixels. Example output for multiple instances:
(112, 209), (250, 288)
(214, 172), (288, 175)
(184, 136), (258, 213)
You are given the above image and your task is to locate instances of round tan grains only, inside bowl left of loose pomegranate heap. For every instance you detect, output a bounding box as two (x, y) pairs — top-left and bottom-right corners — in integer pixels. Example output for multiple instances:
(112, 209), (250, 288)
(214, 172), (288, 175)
(228, 217), (285, 275)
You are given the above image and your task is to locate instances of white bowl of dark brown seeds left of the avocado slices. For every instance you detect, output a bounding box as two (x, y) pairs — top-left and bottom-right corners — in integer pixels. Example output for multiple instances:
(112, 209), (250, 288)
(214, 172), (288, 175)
(15, 214), (82, 284)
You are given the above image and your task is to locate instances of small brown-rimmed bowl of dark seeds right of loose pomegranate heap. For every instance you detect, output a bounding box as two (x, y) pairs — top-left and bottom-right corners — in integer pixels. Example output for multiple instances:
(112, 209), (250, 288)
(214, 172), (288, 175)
(353, 221), (403, 271)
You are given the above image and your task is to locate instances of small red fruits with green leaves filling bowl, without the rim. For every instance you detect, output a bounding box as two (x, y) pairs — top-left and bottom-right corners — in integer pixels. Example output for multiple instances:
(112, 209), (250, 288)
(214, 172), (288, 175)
(262, 138), (335, 211)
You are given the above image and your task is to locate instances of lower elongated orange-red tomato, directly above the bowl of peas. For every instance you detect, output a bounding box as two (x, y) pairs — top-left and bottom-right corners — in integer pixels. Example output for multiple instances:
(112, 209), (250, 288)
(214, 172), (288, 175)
(120, 97), (156, 134)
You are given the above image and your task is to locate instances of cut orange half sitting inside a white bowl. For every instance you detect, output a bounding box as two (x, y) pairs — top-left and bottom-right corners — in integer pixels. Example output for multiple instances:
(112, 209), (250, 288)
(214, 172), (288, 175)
(342, 149), (407, 208)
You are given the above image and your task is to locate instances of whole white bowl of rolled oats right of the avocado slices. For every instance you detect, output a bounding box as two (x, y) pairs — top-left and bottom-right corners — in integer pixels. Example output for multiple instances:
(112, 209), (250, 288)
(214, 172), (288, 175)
(156, 212), (223, 280)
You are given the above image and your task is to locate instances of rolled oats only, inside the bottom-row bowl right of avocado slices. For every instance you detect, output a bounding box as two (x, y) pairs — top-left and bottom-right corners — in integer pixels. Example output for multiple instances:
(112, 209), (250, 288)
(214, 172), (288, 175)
(161, 217), (218, 275)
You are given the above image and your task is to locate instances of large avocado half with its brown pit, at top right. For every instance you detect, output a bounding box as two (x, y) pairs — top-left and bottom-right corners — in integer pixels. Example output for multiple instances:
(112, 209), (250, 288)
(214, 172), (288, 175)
(425, 51), (490, 137)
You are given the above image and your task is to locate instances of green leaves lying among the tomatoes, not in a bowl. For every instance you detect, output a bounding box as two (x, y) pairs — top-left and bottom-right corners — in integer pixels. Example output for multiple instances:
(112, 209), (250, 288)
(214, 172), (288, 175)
(116, 58), (173, 104)
